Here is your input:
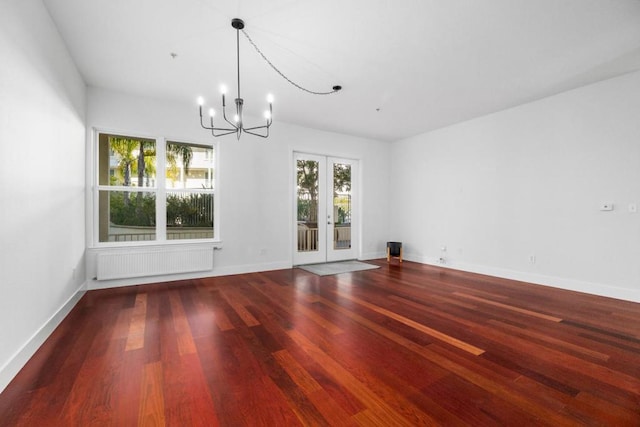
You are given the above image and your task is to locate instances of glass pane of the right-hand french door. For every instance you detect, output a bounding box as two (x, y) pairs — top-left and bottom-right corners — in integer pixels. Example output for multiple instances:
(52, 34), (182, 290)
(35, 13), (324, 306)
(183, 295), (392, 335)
(333, 163), (351, 249)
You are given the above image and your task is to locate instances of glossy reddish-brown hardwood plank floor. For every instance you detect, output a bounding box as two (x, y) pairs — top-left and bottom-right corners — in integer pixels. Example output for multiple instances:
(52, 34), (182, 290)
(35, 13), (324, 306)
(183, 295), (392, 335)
(0, 260), (640, 426)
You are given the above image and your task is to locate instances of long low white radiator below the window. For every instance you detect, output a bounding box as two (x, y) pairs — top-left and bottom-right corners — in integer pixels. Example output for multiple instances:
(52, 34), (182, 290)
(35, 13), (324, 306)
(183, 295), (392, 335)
(96, 247), (213, 280)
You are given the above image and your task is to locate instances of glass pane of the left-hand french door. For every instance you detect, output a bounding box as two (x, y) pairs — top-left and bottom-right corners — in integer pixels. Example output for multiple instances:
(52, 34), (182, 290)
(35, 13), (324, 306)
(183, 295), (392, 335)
(297, 160), (319, 252)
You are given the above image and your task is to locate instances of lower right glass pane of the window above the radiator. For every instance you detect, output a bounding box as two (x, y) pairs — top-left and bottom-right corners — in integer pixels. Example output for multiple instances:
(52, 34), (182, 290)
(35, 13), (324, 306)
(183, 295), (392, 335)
(167, 191), (213, 240)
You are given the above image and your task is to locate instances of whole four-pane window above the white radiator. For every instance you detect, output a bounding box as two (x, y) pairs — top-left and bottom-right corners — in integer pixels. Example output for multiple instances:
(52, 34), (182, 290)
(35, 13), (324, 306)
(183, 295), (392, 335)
(96, 133), (215, 243)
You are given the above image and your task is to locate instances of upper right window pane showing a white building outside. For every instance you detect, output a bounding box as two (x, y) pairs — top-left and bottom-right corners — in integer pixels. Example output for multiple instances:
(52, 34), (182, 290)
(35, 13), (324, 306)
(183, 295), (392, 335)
(166, 141), (215, 190)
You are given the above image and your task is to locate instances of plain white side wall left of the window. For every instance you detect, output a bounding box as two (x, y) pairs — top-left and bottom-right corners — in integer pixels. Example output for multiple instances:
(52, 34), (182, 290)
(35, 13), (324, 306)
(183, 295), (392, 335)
(0, 0), (85, 391)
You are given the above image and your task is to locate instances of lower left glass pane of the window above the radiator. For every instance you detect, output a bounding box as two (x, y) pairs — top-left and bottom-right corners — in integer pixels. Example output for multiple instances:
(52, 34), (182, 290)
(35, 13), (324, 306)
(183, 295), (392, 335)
(98, 190), (156, 242)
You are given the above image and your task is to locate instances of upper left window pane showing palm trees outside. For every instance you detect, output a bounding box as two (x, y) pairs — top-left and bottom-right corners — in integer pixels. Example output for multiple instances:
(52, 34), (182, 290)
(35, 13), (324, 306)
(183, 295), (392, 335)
(98, 134), (156, 187)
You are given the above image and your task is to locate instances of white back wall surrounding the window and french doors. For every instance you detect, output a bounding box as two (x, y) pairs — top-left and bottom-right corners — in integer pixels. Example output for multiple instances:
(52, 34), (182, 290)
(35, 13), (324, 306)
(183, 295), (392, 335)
(87, 88), (390, 288)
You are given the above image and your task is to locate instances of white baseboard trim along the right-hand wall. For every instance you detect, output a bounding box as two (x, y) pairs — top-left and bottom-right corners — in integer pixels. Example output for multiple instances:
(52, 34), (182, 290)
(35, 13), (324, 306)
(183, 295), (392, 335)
(404, 253), (640, 302)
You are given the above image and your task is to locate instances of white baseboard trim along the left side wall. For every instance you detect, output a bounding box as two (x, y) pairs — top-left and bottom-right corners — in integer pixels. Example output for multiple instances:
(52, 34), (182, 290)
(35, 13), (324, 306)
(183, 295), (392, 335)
(0, 282), (87, 393)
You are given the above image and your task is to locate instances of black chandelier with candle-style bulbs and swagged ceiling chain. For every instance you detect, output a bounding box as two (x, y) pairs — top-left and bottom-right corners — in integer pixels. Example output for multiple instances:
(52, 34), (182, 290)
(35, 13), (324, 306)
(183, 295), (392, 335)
(198, 18), (342, 139)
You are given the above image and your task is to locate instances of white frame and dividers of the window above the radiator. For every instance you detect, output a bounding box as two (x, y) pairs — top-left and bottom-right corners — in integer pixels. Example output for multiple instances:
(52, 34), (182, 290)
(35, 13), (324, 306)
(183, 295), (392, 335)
(87, 128), (222, 248)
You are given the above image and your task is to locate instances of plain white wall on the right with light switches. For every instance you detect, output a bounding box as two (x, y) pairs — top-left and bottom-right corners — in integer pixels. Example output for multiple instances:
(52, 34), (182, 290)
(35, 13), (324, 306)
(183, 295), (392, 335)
(390, 72), (640, 301)
